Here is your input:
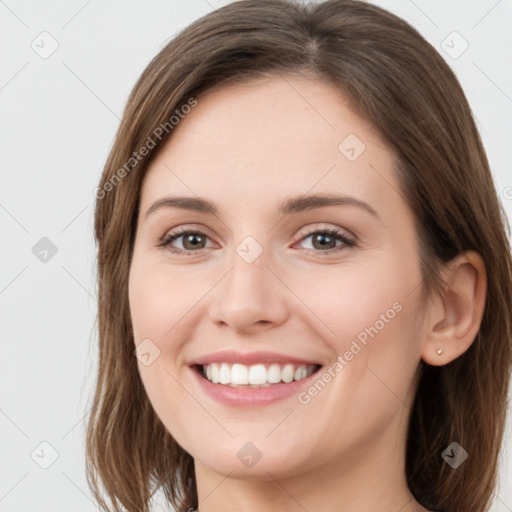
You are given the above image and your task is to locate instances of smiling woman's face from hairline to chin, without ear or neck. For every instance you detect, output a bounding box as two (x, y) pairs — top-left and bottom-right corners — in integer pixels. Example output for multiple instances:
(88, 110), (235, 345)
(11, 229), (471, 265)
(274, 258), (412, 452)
(129, 76), (425, 479)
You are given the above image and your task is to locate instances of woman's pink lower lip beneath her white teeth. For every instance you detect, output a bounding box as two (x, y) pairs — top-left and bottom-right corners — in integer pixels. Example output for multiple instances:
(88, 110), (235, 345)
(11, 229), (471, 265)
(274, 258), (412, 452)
(190, 368), (318, 407)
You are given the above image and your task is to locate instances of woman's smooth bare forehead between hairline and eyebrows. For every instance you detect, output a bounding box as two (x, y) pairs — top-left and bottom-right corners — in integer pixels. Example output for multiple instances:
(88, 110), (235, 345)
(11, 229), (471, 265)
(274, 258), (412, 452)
(142, 76), (398, 218)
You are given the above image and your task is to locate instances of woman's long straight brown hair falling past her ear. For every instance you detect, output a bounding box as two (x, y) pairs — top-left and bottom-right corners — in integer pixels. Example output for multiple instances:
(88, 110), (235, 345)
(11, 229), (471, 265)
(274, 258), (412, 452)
(86, 0), (512, 512)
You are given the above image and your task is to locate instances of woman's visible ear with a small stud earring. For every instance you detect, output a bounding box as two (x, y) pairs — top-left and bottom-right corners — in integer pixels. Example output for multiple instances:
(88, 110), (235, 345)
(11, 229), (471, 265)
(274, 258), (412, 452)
(421, 251), (487, 366)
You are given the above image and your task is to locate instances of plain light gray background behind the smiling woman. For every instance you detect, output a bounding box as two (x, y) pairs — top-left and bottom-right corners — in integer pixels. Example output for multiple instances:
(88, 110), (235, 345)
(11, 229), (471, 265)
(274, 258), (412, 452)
(0, 0), (512, 512)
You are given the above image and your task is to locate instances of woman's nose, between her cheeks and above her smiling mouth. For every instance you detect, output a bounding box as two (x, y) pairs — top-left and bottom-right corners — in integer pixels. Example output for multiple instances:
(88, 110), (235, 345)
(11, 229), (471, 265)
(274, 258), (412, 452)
(210, 242), (288, 333)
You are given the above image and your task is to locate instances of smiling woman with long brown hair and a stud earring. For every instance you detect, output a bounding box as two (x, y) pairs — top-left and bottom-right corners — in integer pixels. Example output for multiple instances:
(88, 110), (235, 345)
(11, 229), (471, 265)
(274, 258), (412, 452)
(87, 0), (512, 512)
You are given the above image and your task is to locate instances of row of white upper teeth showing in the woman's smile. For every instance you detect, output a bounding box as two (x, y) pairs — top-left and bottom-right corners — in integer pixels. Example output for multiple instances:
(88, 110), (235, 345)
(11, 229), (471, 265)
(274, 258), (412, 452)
(203, 363), (316, 387)
